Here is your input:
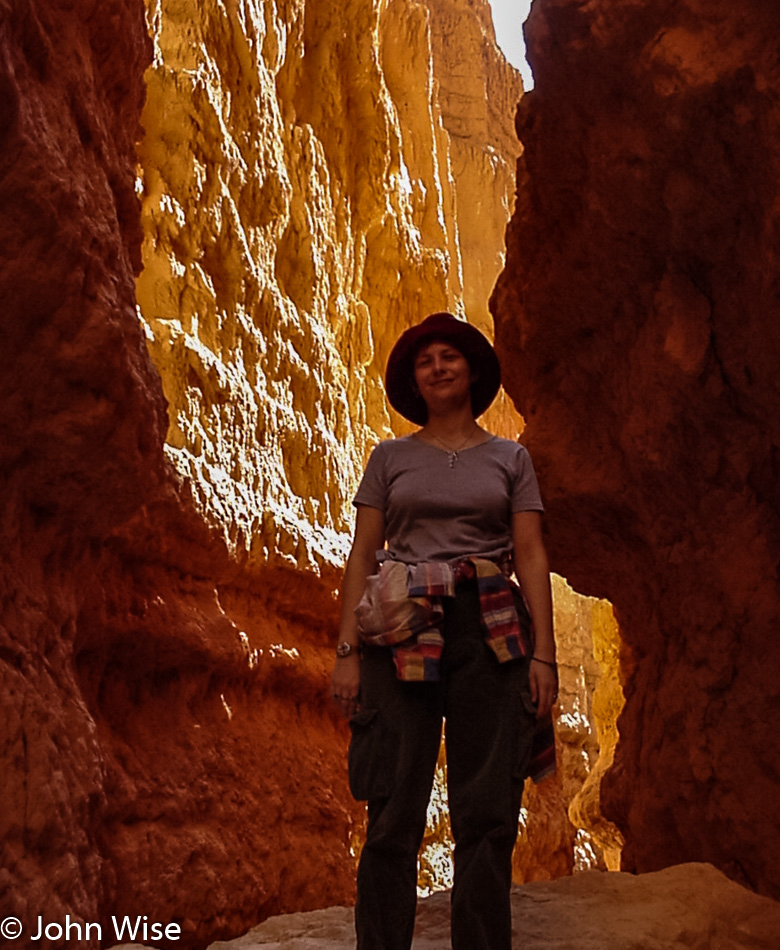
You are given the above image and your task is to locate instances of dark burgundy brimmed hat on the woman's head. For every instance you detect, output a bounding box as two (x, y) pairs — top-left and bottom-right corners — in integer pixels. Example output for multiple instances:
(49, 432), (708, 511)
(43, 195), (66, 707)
(385, 313), (501, 426)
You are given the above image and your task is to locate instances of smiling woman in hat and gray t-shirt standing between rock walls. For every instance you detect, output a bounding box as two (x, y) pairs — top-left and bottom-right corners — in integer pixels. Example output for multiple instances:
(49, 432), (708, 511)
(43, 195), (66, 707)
(331, 313), (557, 950)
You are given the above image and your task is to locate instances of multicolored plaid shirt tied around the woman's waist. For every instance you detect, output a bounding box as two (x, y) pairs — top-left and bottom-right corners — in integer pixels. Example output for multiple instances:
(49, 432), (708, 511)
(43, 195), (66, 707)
(355, 557), (555, 782)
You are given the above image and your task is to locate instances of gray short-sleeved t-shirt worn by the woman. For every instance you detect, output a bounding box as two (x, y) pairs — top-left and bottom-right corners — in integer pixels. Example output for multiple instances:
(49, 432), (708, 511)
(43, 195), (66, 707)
(353, 436), (543, 564)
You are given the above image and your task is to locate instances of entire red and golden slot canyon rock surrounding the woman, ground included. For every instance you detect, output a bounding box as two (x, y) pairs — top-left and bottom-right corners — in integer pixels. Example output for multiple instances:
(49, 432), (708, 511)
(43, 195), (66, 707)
(0, 0), (780, 950)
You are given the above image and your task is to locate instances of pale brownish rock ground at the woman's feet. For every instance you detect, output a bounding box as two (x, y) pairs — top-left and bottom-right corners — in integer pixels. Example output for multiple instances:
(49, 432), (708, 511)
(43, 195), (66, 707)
(115, 864), (780, 950)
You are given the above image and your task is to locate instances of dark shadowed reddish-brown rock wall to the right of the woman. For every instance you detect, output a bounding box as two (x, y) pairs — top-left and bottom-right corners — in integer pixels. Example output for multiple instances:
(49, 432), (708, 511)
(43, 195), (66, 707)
(492, 0), (780, 896)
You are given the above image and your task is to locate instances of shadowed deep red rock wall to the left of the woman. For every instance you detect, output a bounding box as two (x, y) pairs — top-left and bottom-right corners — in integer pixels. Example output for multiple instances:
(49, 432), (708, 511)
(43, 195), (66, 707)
(0, 0), (360, 946)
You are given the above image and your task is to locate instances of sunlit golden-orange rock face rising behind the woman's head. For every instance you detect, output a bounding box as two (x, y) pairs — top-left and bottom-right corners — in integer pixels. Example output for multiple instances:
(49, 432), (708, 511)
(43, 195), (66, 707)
(138, 0), (522, 570)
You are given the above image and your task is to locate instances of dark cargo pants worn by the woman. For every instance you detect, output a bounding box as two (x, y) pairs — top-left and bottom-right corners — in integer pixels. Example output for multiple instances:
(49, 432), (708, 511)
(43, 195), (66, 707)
(350, 583), (535, 950)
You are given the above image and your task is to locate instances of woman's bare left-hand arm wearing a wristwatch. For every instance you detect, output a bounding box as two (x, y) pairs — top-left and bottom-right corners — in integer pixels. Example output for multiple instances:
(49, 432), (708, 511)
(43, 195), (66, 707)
(330, 505), (385, 716)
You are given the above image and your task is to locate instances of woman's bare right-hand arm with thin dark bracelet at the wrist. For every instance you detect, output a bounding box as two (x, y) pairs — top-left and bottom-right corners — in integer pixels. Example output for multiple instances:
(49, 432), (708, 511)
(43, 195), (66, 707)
(512, 511), (558, 719)
